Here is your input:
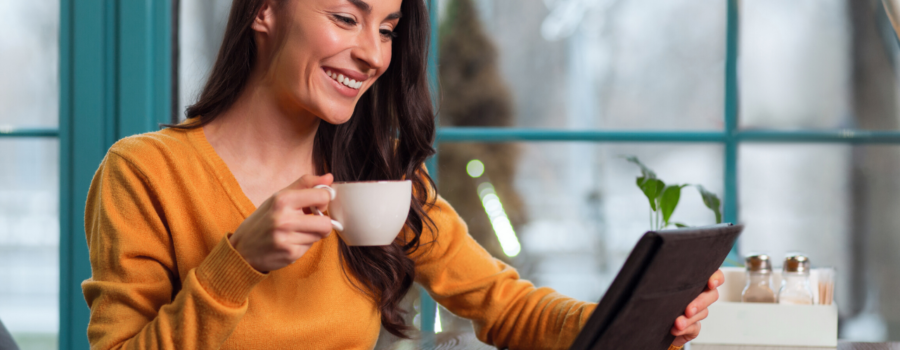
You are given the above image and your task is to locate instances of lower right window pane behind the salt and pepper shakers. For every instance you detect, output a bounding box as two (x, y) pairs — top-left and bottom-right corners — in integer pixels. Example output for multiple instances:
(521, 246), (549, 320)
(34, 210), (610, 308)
(739, 144), (900, 341)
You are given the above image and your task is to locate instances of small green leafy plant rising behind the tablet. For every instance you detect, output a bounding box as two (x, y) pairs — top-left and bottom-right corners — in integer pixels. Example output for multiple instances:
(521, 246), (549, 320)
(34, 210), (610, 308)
(624, 156), (722, 230)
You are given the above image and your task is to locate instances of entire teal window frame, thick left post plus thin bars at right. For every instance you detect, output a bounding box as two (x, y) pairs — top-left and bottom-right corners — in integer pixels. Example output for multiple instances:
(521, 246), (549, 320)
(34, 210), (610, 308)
(0, 0), (900, 349)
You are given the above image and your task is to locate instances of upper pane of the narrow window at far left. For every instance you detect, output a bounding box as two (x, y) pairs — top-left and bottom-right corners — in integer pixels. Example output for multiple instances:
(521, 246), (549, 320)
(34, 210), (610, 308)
(0, 0), (59, 129)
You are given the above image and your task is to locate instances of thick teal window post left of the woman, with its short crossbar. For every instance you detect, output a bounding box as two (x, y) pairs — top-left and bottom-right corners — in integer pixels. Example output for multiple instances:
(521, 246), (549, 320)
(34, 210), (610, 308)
(6, 0), (174, 350)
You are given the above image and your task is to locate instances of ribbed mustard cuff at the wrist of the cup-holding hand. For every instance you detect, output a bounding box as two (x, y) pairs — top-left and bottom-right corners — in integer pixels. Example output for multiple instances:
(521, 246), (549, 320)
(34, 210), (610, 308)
(196, 235), (267, 306)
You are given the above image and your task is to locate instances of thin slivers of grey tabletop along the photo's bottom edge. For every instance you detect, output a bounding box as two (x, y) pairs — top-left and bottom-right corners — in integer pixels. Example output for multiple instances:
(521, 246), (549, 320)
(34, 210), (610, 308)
(388, 332), (900, 350)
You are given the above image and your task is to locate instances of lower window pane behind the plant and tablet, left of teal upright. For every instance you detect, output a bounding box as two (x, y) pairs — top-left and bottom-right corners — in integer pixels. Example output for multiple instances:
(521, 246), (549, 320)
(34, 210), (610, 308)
(438, 143), (723, 330)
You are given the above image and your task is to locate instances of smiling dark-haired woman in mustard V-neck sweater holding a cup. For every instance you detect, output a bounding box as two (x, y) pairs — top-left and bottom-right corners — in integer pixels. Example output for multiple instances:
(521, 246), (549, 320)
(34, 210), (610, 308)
(83, 0), (723, 349)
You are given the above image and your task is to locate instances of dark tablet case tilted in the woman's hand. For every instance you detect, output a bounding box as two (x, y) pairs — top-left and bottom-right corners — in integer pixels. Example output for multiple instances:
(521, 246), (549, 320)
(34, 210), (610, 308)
(570, 224), (744, 350)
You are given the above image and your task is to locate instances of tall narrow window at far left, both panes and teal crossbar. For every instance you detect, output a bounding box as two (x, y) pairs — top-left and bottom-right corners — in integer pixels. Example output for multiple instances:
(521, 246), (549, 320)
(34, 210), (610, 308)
(0, 0), (59, 349)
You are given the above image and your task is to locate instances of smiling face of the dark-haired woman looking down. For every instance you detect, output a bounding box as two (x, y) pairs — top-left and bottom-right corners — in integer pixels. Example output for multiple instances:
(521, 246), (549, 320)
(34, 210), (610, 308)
(266, 0), (402, 124)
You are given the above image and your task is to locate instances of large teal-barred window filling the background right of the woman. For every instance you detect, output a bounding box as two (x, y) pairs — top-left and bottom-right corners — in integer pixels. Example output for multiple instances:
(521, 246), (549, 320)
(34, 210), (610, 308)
(426, 0), (900, 340)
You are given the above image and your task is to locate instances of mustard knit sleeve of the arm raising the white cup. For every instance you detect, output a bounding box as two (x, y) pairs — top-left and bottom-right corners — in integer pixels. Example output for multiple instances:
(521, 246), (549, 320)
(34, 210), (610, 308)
(82, 146), (265, 350)
